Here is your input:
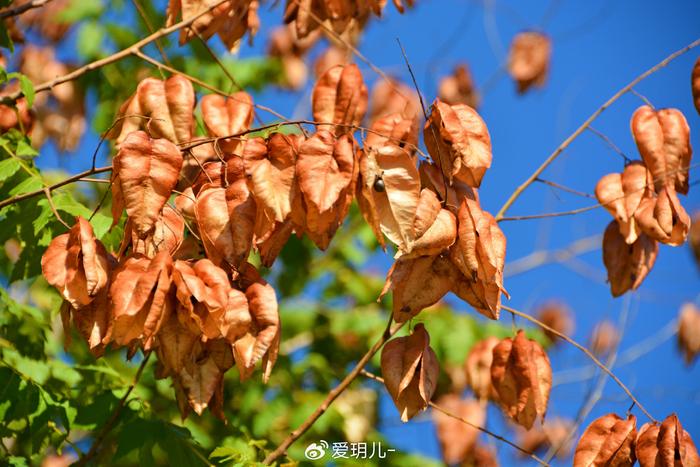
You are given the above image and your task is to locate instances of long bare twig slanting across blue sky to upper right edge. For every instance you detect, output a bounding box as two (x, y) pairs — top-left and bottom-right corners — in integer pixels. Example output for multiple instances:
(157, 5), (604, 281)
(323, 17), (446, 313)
(496, 39), (700, 220)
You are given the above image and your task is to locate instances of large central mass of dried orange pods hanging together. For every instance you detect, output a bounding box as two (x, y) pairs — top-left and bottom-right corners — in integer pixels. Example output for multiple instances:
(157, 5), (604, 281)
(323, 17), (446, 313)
(43, 60), (505, 416)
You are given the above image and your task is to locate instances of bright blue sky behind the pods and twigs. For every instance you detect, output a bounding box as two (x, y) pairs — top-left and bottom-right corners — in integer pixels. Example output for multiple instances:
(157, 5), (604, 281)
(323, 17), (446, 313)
(34, 0), (700, 465)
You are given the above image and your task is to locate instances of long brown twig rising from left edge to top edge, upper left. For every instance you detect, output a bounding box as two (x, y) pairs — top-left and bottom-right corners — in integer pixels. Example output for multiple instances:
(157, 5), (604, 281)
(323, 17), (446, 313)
(0, 0), (229, 105)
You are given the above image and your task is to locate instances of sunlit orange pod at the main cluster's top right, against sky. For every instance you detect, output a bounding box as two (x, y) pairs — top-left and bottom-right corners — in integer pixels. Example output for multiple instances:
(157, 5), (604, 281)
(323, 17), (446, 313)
(423, 99), (492, 188)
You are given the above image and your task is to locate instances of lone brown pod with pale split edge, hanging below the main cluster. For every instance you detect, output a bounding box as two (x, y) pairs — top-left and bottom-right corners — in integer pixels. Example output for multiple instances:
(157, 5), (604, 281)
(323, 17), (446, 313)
(381, 323), (440, 422)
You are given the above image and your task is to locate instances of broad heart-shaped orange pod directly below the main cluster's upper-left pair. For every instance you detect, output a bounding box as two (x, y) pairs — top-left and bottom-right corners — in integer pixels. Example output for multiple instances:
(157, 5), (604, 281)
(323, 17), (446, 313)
(112, 131), (182, 239)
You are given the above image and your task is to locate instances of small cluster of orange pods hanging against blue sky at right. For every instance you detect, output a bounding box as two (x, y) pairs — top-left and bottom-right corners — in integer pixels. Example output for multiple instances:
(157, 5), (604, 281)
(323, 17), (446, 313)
(596, 105), (692, 296)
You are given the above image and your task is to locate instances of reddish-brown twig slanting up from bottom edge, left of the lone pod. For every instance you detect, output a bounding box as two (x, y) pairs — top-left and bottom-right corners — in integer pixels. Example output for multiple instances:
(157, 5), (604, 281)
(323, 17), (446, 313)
(263, 317), (406, 465)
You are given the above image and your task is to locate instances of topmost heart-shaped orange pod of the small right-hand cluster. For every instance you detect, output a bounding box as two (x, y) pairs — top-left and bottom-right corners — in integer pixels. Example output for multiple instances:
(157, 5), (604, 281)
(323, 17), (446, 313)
(630, 105), (693, 194)
